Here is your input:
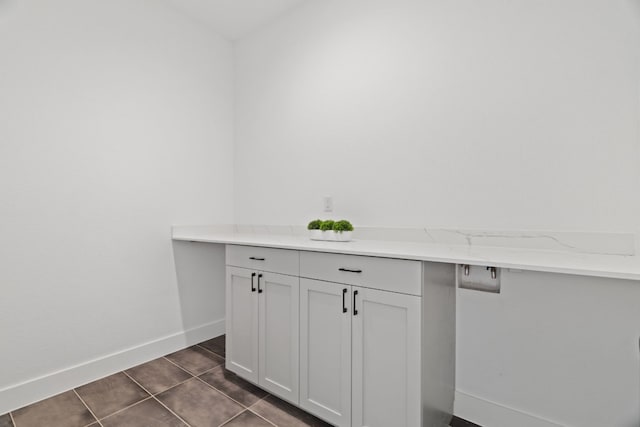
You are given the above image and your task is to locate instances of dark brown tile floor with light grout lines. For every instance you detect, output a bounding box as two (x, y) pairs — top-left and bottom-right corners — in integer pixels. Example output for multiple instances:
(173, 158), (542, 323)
(0, 335), (475, 427)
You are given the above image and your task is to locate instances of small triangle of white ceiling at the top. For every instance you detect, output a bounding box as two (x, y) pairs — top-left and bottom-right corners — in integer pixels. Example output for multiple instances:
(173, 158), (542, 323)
(165, 0), (306, 40)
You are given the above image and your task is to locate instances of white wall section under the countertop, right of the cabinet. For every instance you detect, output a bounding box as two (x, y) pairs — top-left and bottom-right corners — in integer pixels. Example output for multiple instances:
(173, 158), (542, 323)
(454, 270), (640, 427)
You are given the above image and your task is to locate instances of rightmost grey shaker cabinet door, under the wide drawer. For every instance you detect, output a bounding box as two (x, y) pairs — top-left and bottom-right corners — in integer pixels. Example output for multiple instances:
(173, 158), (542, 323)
(352, 286), (421, 427)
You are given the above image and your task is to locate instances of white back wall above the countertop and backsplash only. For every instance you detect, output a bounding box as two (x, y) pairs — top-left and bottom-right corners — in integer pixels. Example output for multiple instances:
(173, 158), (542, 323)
(236, 0), (640, 231)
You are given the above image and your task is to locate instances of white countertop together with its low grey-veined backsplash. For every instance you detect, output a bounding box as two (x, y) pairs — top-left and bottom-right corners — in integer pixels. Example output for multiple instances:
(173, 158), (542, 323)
(172, 225), (640, 280)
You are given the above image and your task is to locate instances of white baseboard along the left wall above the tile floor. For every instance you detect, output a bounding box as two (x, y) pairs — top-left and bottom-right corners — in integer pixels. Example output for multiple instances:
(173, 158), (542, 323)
(0, 319), (225, 414)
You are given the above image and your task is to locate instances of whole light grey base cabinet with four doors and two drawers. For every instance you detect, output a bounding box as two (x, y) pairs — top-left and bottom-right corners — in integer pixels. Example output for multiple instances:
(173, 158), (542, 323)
(226, 245), (455, 427)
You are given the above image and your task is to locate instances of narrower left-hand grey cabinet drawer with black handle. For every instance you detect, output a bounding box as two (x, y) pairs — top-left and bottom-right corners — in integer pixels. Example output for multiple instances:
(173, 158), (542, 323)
(226, 245), (300, 276)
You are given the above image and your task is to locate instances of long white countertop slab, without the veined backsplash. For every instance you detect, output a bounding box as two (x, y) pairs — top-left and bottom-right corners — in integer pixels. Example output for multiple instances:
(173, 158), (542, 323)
(172, 226), (640, 280)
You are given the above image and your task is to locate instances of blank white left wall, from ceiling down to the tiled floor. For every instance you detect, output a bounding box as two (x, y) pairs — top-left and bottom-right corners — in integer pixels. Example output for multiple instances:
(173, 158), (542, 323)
(0, 0), (233, 413)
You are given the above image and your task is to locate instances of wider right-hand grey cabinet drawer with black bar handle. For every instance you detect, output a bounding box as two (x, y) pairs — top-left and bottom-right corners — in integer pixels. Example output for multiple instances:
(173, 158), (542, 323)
(300, 251), (422, 295)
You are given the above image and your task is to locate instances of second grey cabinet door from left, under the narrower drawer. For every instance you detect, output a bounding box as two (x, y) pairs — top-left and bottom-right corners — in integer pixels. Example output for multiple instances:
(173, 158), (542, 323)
(258, 273), (300, 404)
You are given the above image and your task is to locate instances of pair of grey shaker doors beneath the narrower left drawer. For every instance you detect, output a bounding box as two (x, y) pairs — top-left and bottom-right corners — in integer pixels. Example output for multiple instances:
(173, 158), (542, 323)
(225, 247), (299, 403)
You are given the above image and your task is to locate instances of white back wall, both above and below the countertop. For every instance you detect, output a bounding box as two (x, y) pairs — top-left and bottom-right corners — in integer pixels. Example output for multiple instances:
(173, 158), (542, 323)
(235, 0), (640, 427)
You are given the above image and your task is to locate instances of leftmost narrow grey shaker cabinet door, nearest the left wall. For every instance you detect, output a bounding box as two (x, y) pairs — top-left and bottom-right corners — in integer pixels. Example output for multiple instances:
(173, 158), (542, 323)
(225, 267), (258, 383)
